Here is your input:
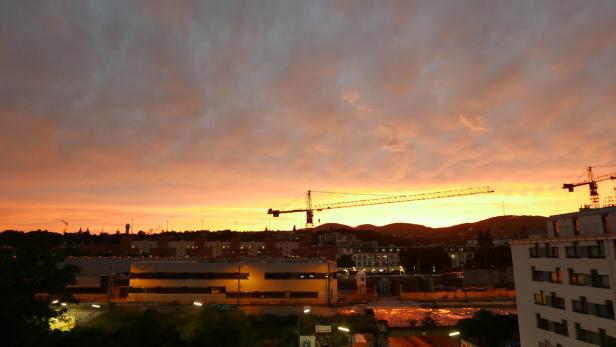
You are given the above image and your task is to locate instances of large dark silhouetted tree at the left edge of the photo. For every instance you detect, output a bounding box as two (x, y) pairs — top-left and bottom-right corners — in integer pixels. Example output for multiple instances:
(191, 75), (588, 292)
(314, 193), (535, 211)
(0, 232), (78, 346)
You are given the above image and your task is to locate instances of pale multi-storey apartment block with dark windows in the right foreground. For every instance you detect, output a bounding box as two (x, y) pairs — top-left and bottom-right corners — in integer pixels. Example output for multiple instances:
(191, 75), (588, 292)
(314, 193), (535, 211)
(511, 207), (616, 347)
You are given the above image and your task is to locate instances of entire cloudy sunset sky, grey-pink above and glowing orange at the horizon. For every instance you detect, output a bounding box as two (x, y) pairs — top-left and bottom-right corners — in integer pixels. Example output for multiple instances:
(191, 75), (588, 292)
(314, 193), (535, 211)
(0, 0), (616, 232)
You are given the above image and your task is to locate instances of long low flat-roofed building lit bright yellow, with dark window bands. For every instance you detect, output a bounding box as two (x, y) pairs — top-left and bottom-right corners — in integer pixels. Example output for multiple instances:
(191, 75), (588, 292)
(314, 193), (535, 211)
(127, 259), (338, 304)
